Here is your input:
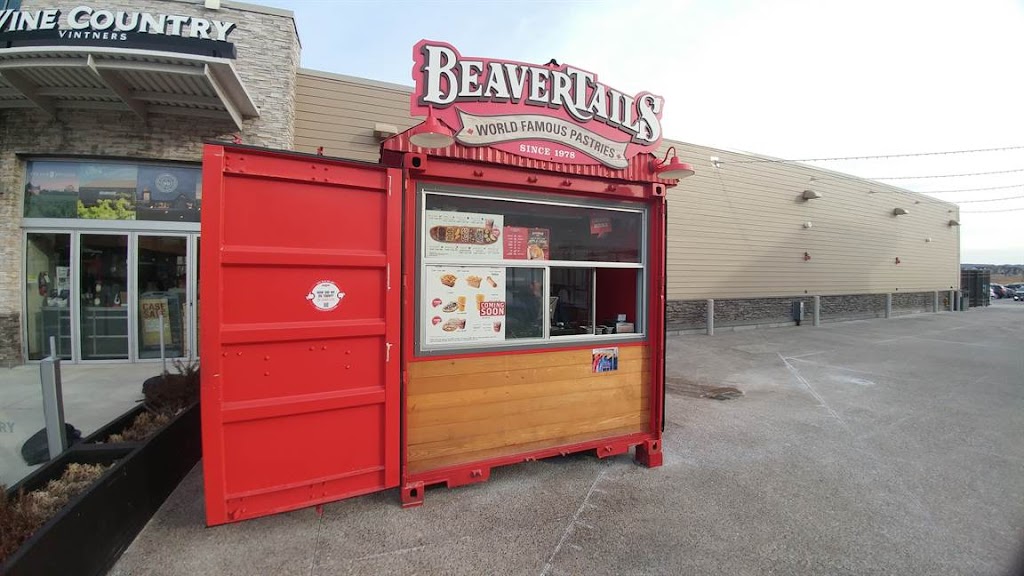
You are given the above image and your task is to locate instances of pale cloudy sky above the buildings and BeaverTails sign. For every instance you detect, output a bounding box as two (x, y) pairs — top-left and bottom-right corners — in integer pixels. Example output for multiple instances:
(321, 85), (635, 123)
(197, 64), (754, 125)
(255, 0), (1024, 263)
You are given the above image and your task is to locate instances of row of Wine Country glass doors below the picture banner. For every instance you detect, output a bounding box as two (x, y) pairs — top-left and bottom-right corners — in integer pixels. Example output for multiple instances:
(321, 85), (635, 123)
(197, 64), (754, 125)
(24, 230), (200, 362)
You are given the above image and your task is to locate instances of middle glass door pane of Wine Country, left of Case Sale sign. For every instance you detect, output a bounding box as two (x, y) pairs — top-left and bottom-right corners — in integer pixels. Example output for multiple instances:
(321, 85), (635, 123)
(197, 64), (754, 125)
(76, 234), (129, 360)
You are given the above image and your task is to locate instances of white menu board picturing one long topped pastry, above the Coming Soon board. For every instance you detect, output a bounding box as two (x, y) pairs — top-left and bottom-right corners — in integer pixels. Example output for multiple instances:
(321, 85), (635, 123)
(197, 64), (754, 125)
(423, 210), (504, 260)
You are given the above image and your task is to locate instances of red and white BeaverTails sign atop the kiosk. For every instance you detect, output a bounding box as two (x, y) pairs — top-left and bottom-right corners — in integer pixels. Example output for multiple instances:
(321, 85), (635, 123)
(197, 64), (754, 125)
(412, 40), (665, 169)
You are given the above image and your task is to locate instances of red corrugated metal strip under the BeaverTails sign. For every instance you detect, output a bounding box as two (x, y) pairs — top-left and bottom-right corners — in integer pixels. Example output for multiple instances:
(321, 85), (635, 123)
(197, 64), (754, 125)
(382, 130), (675, 186)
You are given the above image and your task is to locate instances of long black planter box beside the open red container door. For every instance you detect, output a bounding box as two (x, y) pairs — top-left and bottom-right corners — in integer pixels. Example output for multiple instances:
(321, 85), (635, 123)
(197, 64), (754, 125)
(0, 405), (201, 576)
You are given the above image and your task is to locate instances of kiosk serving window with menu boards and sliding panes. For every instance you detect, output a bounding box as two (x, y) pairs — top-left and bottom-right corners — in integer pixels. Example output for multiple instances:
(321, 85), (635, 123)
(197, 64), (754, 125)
(418, 191), (645, 352)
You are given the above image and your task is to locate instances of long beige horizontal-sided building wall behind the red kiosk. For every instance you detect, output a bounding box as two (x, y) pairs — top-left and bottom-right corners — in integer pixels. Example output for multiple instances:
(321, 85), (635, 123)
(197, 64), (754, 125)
(295, 70), (959, 300)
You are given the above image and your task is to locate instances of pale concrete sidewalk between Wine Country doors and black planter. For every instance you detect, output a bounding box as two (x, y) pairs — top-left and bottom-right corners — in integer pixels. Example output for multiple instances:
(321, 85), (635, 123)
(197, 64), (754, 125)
(0, 361), (157, 486)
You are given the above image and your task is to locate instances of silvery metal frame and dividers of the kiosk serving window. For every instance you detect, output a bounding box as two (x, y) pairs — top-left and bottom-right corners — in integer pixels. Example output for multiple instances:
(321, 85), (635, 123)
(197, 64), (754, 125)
(412, 183), (650, 357)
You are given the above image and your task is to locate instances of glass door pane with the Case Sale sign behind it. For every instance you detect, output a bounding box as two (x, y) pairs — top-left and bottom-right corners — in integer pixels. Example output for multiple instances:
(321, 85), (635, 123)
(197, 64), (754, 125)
(136, 235), (191, 359)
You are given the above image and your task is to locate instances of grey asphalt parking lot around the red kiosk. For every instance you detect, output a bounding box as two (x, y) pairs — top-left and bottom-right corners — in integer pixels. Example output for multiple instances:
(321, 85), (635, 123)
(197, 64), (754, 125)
(112, 301), (1024, 576)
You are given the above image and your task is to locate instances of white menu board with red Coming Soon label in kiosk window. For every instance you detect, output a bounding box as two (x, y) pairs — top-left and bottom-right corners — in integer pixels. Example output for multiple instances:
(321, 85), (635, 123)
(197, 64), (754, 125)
(420, 265), (505, 345)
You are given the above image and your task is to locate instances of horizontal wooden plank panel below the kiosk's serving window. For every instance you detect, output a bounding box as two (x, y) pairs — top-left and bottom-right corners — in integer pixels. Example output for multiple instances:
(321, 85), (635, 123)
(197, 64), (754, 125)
(406, 345), (650, 474)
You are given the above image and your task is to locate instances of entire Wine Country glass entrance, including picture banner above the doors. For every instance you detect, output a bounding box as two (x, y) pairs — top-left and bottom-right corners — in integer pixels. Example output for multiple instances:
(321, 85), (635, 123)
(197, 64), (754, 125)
(24, 158), (202, 360)
